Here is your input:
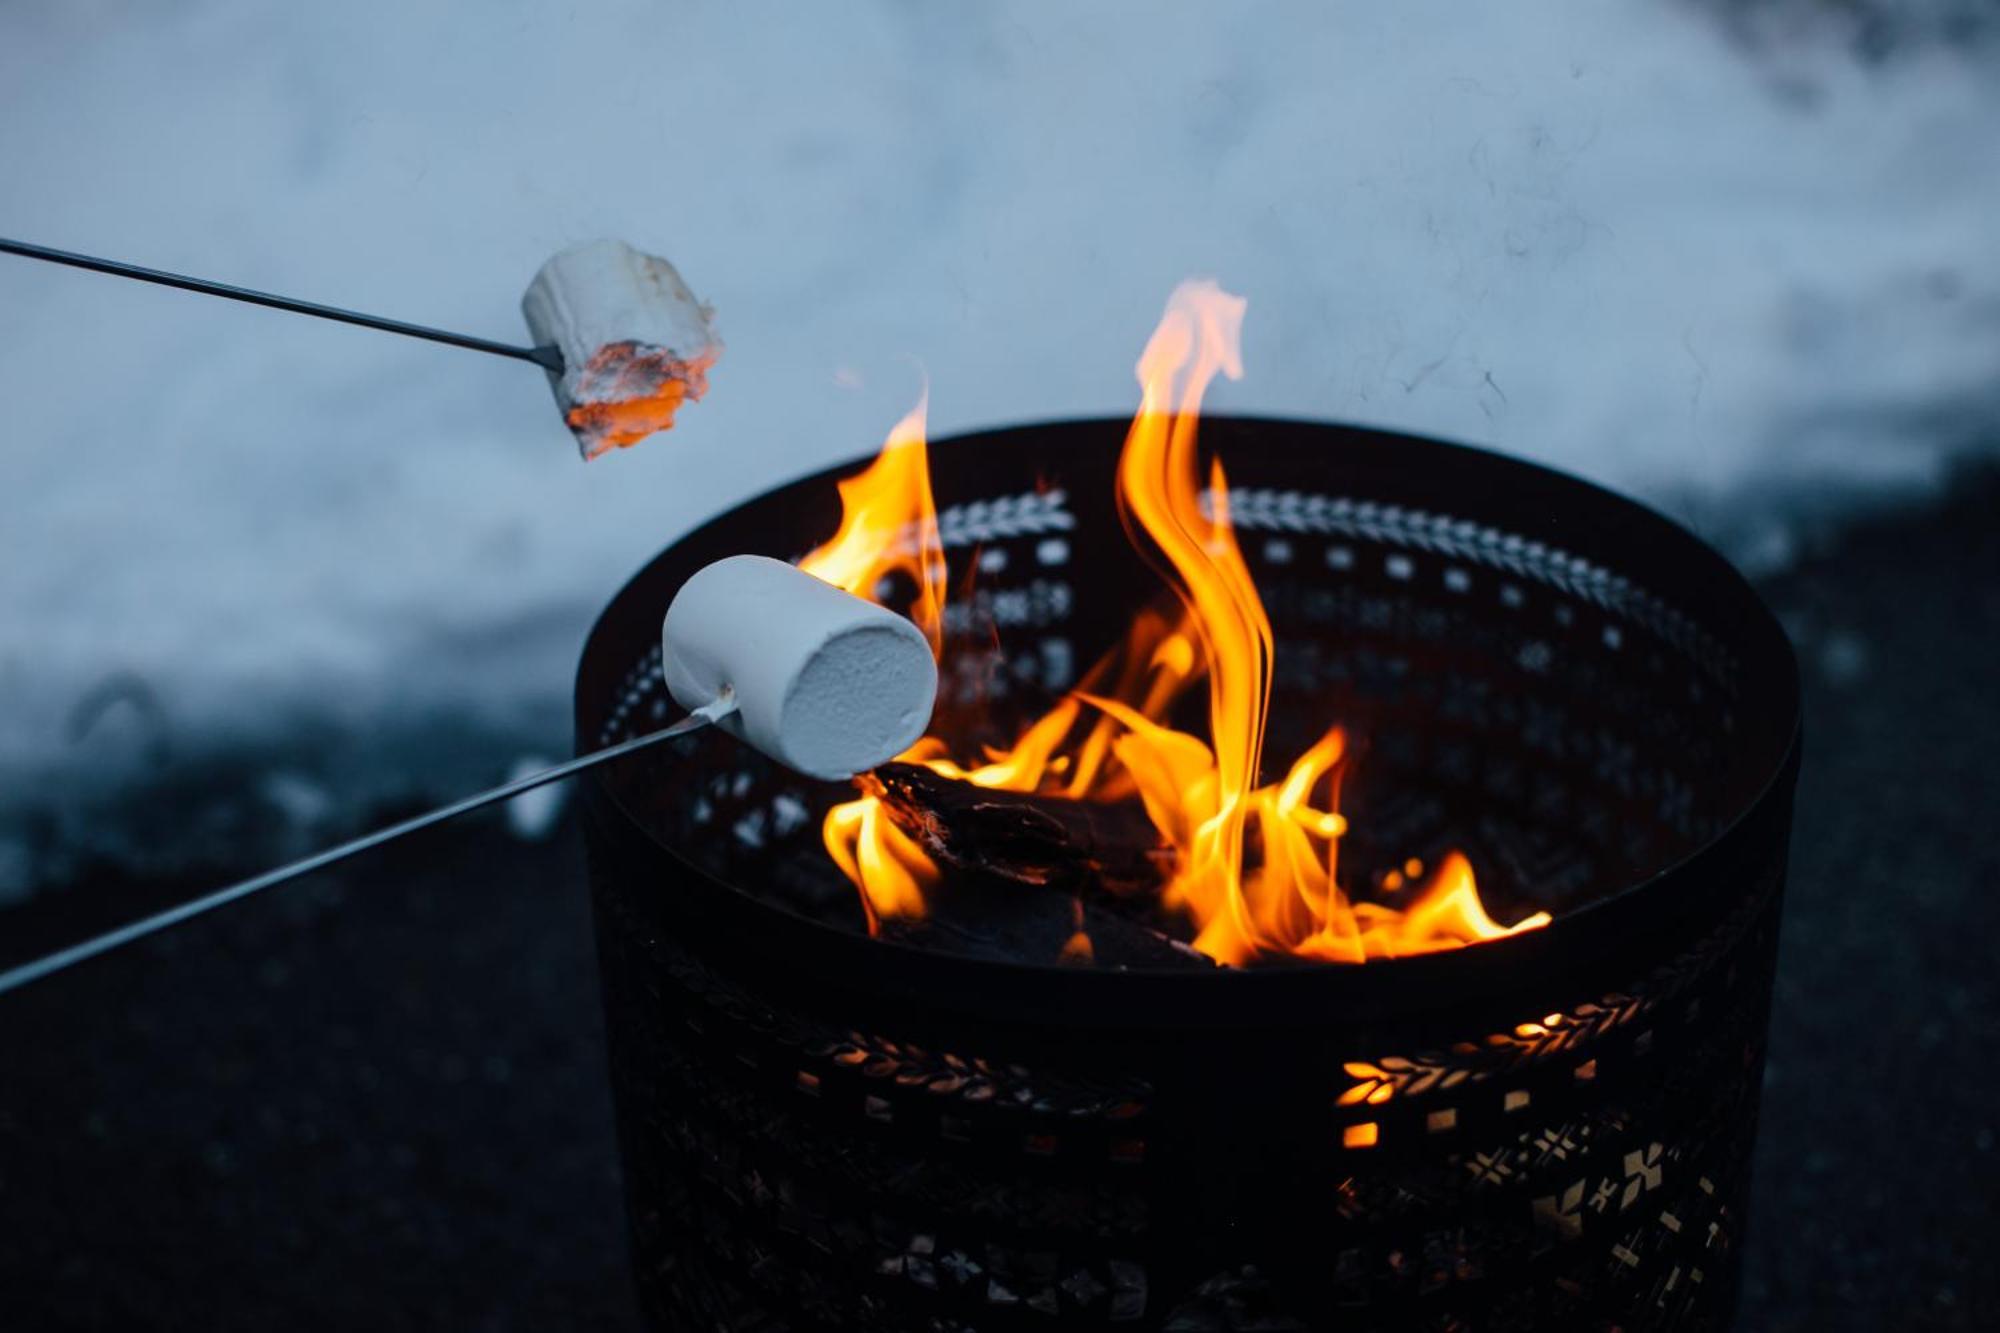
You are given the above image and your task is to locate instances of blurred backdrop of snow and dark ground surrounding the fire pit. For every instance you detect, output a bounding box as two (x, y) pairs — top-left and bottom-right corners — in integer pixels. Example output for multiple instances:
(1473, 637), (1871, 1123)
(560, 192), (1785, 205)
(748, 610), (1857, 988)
(0, 0), (2000, 1329)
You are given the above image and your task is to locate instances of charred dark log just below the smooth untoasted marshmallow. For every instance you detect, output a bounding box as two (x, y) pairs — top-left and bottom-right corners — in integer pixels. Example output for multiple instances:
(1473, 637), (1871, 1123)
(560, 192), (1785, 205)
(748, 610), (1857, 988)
(858, 763), (1174, 897)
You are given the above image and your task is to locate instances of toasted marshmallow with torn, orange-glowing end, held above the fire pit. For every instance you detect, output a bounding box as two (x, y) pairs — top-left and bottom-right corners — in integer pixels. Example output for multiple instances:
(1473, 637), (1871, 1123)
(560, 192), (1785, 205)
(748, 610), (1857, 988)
(520, 240), (722, 458)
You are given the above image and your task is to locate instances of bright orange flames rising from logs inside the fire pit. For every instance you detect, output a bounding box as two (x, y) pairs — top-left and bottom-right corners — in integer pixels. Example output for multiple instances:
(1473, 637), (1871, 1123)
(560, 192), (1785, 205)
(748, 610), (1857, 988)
(802, 282), (1548, 965)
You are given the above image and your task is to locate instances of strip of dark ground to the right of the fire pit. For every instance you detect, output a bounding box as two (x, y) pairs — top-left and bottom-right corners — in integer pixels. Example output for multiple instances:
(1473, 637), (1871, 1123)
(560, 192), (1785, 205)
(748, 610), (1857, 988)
(1742, 462), (2000, 1331)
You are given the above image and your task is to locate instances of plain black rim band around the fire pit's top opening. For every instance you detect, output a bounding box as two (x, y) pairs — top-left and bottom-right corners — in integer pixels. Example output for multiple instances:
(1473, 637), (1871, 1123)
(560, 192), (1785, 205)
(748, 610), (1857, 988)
(576, 414), (1802, 1027)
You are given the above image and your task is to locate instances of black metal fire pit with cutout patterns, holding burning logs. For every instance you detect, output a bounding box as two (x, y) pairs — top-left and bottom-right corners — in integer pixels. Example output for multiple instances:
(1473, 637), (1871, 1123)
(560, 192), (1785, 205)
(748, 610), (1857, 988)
(576, 418), (1798, 1333)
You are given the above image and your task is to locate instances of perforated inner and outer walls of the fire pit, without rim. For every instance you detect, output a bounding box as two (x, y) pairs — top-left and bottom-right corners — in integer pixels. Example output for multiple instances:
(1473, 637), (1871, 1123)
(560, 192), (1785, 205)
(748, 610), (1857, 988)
(592, 452), (1782, 1333)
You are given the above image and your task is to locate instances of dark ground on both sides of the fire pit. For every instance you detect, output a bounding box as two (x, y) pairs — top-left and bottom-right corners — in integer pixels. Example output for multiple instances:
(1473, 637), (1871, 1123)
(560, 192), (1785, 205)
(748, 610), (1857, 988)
(0, 474), (2000, 1333)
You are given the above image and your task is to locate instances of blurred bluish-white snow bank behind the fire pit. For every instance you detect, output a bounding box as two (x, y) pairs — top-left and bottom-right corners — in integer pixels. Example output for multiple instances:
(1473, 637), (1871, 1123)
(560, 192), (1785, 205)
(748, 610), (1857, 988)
(0, 0), (2000, 880)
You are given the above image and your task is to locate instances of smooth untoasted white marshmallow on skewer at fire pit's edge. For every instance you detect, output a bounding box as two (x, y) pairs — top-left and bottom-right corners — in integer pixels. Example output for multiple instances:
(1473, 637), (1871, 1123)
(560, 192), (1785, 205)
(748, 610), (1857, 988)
(660, 556), (938, 779)
